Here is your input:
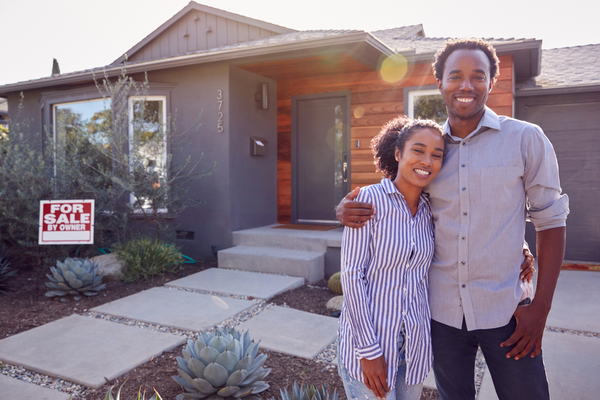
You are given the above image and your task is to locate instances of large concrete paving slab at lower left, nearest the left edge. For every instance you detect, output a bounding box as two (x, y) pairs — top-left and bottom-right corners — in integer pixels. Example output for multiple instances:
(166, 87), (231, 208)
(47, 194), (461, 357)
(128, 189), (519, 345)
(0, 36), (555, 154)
(0, 315), (187, 388)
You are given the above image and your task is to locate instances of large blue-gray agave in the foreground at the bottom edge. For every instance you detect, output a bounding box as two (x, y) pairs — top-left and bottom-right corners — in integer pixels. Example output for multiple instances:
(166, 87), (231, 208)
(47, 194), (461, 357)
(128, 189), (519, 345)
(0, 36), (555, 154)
(173, 329), (271, 400)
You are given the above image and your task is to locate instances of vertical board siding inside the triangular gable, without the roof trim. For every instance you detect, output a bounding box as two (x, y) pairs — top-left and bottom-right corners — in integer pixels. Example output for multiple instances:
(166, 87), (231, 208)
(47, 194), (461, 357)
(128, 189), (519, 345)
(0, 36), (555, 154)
(129, 10), (278, 62)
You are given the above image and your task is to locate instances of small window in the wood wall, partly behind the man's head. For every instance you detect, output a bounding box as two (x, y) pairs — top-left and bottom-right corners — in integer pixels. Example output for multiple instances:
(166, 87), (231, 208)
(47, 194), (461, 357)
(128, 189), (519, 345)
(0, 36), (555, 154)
(404, 85), (448, 124)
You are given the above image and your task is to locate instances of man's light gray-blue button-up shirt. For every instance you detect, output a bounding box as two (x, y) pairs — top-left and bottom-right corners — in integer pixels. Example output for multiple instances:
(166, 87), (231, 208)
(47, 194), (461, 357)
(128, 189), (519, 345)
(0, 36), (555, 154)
(424, 107), (569, 330)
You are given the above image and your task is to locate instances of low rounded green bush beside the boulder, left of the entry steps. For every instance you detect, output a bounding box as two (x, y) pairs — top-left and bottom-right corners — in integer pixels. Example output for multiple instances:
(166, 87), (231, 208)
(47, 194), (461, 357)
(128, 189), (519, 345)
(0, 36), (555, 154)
(115, 236), (183, 282)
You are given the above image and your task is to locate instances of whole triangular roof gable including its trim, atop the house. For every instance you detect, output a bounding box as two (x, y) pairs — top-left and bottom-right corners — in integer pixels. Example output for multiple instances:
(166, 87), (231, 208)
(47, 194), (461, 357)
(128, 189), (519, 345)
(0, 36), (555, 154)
(112, 1), (293, 65)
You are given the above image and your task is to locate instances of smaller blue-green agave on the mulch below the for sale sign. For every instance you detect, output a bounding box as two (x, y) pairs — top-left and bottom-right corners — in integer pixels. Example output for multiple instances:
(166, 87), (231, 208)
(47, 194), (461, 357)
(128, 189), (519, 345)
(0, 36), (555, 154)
(46, 258), (106, 299)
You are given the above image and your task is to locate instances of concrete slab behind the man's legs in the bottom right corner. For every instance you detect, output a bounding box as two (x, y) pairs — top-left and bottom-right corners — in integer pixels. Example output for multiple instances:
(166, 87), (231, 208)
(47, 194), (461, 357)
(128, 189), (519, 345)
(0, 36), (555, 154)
(477, 330), (600, 400)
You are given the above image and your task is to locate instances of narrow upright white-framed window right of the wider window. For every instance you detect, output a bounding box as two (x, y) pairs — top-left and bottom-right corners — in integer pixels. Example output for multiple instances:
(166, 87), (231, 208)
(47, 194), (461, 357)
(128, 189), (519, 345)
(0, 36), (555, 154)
(129, 96), (167, 212)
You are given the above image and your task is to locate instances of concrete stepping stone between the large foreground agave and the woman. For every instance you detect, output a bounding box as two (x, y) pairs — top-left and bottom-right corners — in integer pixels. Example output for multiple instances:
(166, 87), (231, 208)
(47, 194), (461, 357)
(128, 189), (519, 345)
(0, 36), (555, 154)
(235, 306), (338, 359)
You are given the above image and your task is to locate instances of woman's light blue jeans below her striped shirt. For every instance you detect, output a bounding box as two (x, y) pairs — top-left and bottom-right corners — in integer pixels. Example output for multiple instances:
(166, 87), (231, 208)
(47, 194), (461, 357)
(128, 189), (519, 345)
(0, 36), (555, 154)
(338, 328), (423, 400)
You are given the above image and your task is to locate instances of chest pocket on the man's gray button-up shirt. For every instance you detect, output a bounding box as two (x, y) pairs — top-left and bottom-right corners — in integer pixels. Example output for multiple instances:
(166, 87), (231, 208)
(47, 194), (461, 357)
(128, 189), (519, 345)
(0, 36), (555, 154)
(480, 167), (523, 208)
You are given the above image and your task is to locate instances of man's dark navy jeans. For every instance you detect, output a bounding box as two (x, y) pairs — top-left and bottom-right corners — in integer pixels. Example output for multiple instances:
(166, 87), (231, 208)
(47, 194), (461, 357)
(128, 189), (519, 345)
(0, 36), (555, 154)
(431, 317), (550, 400)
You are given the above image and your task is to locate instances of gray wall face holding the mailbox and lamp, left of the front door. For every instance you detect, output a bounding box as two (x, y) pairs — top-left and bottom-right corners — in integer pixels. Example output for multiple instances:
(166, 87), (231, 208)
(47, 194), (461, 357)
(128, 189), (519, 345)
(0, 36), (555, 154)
(229, 67), (277, 231)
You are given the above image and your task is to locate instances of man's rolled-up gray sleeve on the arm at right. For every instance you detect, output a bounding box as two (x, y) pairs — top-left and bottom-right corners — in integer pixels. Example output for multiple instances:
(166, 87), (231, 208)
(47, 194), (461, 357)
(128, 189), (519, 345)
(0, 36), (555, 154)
(523, 125), (569, 231)
